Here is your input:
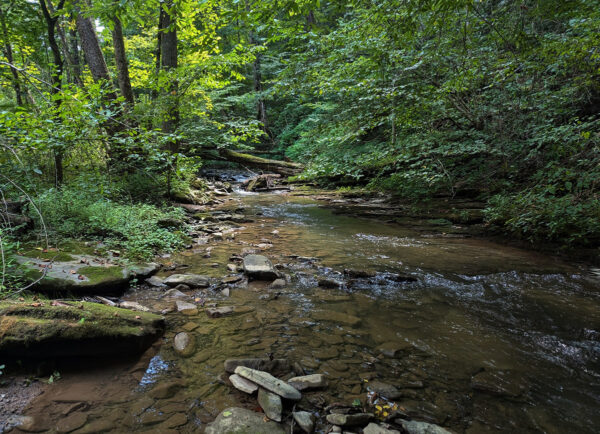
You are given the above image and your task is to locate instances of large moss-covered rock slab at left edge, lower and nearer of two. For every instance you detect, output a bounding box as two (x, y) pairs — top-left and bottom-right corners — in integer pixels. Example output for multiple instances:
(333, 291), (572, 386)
(0, 301), (165, 358)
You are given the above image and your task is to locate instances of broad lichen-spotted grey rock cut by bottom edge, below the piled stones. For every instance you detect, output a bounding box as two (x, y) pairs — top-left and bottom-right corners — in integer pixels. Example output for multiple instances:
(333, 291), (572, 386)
(205, 407), (286, 434)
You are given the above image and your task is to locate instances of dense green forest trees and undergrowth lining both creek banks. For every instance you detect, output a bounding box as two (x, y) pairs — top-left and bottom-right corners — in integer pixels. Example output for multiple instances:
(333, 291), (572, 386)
(0, 0), (600, 288)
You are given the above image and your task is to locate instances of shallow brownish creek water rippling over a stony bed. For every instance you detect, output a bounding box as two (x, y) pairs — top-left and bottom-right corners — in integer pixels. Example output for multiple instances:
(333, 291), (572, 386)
(14, 194), (600, 433)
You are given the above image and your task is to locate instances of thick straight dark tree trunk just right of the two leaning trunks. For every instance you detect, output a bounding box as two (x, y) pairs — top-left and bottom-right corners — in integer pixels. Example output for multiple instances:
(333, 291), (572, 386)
(160, 0), (179, 146)
